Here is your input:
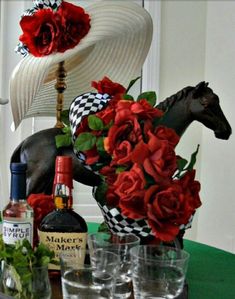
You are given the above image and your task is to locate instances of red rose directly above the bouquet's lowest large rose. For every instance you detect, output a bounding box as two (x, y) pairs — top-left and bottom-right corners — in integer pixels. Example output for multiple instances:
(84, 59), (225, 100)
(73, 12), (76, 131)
(132, 132), (177, 185)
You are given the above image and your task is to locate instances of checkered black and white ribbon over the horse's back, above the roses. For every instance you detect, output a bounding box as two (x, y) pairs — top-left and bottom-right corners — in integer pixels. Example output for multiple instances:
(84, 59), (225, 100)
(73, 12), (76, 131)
(69, 92), (111, 162)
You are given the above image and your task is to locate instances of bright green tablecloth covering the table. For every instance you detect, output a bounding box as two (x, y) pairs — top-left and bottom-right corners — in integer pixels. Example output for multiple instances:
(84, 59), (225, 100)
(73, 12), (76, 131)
(88, 223), (235, 299)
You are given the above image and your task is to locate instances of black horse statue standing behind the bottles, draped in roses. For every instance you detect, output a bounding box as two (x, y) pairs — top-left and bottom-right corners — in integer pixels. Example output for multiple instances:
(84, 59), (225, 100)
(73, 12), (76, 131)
(11, 82), (232, 195)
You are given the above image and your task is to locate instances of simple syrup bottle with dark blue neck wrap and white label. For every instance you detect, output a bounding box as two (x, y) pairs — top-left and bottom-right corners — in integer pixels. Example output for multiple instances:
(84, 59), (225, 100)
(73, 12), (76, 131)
(2, 163), (33, 245)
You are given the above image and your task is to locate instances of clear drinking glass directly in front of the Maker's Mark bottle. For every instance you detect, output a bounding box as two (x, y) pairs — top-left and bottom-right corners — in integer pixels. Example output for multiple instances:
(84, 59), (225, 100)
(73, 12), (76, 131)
(60, 249), (119, 299)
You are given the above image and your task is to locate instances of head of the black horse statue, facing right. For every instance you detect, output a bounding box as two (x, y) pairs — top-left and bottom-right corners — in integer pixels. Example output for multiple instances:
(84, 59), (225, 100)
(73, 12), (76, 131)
(190, 82), (232, 139)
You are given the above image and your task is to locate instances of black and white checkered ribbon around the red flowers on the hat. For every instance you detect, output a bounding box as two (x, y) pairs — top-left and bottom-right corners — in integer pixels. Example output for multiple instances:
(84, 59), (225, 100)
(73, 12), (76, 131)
(15, 0), (63, 57)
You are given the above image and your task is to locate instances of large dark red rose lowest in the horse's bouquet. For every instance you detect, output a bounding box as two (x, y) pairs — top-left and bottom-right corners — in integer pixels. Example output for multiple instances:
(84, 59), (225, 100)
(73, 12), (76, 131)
(145, 183), (192, 241)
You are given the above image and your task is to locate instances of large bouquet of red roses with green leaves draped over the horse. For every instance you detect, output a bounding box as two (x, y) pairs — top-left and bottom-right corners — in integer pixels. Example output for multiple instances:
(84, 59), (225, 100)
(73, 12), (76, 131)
(70, 77), (201, 242)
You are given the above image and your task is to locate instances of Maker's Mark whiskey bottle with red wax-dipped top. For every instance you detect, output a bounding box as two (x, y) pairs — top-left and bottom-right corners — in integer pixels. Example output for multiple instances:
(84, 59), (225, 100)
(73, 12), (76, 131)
(38, 156), (87, 270)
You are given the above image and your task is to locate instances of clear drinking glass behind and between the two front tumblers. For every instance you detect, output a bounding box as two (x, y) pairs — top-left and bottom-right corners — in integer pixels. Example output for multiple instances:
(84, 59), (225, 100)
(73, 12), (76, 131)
(88, 233), (140, 299)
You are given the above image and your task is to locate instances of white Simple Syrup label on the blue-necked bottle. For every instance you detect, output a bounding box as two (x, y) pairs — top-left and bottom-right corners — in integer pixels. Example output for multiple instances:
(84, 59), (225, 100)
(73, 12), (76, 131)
(2, 219), (33, 245)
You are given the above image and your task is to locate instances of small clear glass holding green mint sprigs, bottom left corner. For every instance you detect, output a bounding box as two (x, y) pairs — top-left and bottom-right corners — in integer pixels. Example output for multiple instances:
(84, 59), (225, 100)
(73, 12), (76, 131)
(0, 261), (51, 299)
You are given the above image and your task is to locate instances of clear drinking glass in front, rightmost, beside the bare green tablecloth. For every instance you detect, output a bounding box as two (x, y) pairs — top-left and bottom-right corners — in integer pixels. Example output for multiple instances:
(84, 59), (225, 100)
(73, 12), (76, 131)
(130, 245), (189, 299)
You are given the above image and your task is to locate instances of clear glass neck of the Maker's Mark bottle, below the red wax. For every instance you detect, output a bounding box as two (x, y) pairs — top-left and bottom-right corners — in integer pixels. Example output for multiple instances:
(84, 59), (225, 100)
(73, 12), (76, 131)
(54, 183), (73, 210)
